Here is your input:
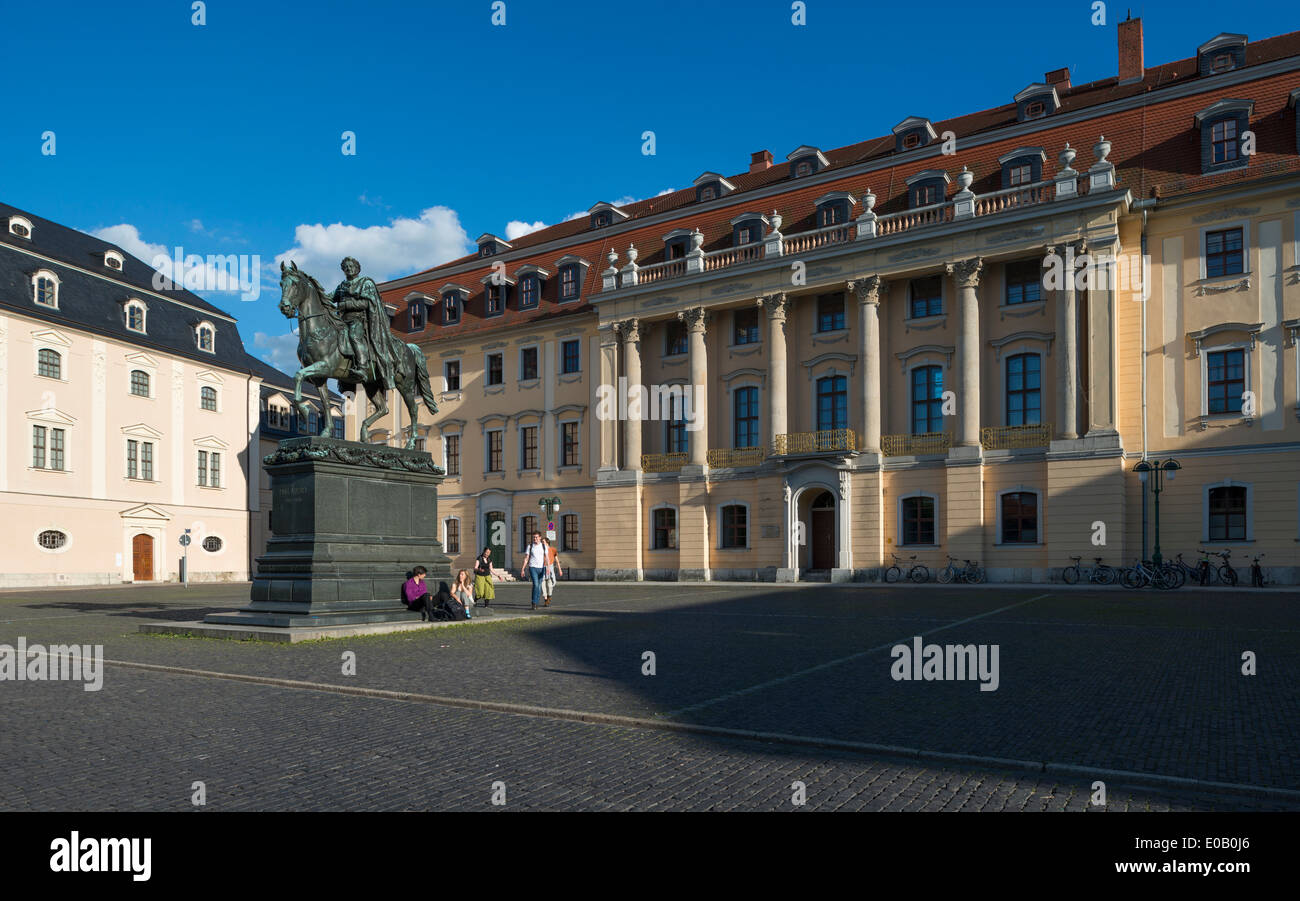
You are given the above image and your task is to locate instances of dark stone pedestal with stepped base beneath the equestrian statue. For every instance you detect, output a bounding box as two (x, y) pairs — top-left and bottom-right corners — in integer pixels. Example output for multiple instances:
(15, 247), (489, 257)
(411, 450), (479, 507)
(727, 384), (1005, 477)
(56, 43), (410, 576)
(204, 437), (451, 628)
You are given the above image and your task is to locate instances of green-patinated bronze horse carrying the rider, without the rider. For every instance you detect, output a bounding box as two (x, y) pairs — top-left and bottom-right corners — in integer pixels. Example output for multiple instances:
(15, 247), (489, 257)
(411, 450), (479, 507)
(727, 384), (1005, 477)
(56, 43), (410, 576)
(280, 263), (438, 450)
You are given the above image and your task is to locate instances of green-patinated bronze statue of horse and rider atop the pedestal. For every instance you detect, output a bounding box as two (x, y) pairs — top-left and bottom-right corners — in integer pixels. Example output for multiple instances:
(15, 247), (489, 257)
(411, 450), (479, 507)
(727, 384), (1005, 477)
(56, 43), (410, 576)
(280, 256), (438, 450)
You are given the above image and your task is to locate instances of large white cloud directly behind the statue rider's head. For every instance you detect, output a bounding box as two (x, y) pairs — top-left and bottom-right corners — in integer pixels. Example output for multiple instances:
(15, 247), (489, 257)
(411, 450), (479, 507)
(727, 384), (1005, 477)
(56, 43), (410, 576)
(274, 207), (473, 285)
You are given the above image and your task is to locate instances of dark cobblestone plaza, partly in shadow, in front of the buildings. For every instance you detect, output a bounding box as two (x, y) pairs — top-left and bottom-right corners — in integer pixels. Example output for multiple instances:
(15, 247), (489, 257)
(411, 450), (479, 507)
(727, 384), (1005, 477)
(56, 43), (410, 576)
(0, 582), (1300, 810)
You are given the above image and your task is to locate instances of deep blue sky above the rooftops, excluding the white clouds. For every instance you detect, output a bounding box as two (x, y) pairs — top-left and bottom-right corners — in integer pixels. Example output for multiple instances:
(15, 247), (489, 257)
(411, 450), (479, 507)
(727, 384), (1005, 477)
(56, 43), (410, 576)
(0, 0), (1296, 367)
